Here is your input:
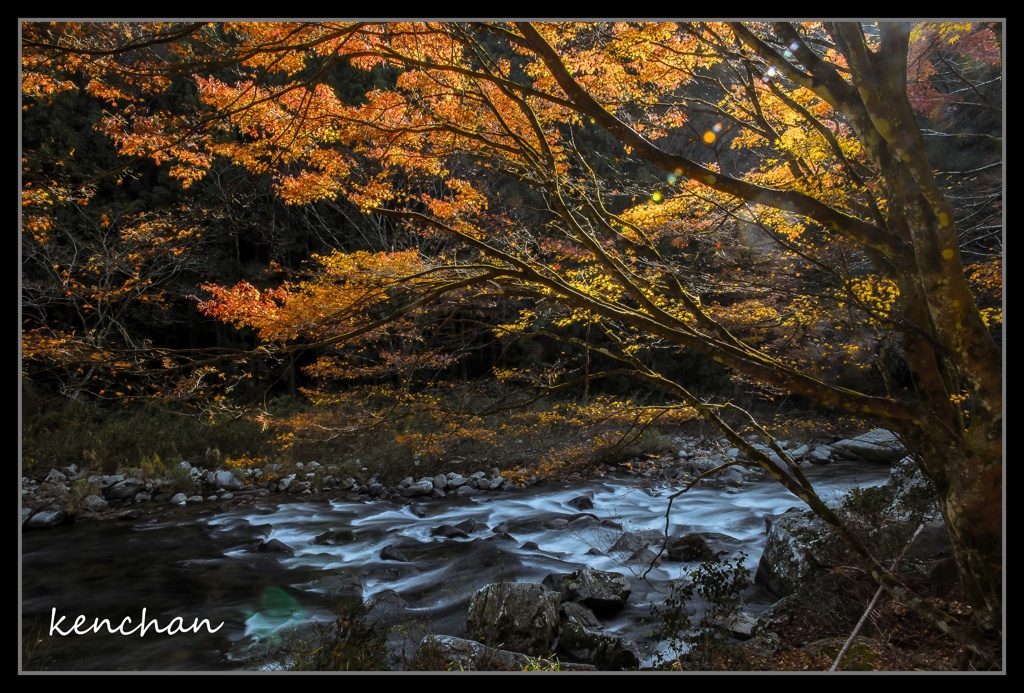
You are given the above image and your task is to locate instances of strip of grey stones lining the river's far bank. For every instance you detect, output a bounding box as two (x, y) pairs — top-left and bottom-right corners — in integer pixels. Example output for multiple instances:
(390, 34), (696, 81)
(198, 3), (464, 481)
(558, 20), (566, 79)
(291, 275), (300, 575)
(22, 423), (905, 529)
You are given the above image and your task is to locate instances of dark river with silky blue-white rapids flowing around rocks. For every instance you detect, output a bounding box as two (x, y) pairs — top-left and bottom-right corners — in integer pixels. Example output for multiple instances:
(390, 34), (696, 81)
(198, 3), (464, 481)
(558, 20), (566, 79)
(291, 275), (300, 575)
(20, 462), (888, 672)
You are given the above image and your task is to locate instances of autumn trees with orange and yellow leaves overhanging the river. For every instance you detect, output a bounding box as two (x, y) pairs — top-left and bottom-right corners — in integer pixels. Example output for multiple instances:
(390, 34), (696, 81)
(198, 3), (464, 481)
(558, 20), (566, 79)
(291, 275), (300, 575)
(22, 21), (1004, 660)
